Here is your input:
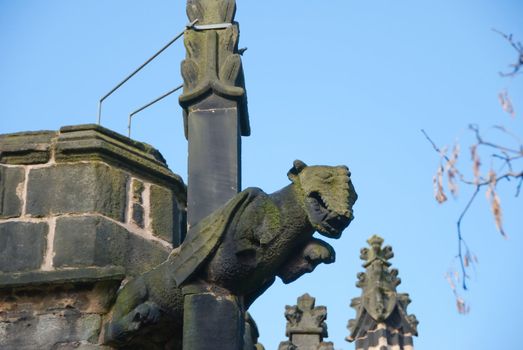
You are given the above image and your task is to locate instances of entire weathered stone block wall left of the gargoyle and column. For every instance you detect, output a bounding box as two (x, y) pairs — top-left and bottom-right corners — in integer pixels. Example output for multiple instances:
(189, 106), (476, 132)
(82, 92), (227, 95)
(0, 125), (186, 349)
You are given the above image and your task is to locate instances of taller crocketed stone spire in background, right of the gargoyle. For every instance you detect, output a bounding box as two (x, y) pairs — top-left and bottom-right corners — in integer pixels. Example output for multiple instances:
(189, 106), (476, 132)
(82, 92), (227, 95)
(346, 235), (418, 350)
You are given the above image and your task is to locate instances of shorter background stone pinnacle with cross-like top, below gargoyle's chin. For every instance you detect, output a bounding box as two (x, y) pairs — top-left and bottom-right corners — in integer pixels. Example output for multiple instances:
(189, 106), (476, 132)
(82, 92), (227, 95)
(278, 294), (334, 350)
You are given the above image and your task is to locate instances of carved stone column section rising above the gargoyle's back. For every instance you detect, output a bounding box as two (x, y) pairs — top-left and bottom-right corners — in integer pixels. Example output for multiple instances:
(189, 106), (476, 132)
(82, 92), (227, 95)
(180, 0), (250, 227)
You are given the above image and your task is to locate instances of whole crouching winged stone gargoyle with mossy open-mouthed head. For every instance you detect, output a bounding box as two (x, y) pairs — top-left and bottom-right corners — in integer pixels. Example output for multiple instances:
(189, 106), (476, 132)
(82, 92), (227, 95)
(104, 161), (357, 349)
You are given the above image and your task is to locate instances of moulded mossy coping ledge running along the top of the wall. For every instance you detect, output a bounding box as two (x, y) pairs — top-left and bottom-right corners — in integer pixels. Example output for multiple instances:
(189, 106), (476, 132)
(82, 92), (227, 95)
(0, 124), (187, 206)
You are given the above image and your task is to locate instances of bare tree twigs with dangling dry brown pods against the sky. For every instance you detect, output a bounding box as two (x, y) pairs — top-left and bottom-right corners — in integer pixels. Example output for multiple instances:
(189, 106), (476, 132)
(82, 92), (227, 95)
(421, 29), (523, 313)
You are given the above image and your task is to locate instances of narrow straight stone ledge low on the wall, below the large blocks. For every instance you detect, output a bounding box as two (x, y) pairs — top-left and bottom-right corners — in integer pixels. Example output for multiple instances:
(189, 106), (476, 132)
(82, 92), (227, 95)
(0, 266), (125, 289)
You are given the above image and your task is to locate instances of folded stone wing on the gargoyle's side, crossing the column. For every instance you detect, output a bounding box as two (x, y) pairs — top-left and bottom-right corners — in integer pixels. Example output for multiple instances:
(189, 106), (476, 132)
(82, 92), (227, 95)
(172, 189), (257, 286)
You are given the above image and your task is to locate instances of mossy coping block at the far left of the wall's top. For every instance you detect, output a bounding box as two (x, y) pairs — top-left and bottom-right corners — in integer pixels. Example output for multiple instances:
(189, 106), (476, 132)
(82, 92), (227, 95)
(0, 131), (57, 164)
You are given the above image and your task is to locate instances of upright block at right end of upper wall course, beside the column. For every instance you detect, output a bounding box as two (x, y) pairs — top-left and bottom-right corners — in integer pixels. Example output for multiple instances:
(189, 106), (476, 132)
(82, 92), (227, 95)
(150, 185), (181, 247)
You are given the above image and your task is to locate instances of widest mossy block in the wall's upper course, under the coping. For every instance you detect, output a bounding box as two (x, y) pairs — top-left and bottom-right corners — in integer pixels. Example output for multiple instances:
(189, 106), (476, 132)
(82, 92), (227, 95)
(27, 162), (128, 221)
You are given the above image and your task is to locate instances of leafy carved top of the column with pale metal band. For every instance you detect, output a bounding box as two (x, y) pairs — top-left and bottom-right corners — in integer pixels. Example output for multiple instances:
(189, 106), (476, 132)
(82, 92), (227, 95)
(179, 0), (250, 137)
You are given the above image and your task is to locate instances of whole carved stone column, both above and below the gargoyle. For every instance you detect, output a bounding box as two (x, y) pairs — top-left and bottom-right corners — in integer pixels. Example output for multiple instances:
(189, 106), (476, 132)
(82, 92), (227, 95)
(179, 0), (250, 350)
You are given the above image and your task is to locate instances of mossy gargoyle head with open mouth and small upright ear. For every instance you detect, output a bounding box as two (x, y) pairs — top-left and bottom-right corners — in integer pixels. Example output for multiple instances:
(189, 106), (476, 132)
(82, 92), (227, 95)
(287, 160), (358, 238)
